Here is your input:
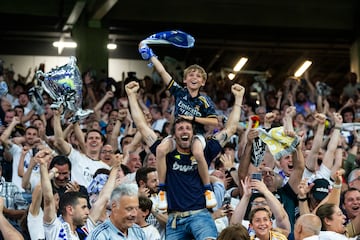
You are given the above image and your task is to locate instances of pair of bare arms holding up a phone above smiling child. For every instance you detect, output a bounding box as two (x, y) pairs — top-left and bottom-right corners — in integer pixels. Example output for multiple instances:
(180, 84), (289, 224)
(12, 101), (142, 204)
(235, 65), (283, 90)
(230, 175), (291, 236)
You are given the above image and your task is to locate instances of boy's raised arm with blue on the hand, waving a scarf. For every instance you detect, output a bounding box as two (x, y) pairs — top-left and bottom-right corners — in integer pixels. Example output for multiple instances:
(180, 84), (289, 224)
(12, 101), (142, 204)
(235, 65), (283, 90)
(139, 42), (172, 86)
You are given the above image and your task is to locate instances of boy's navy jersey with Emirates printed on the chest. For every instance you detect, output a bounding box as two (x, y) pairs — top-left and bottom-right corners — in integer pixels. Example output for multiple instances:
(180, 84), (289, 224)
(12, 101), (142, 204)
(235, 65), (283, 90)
(168, 80), (217, 134)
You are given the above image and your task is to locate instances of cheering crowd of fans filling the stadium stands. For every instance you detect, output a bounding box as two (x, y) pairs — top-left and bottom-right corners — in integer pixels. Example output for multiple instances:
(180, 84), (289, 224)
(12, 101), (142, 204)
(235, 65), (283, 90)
(0, 52), (360, 240)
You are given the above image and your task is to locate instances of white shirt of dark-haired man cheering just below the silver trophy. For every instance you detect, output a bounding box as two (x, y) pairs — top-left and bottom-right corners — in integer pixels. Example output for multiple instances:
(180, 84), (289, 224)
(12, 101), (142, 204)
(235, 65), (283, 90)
(68, 145), (110, 188)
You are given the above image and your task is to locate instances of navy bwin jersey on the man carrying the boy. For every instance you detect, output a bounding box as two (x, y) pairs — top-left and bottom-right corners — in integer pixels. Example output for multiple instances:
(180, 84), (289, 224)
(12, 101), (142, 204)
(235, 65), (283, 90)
(150, 139), (222, 212)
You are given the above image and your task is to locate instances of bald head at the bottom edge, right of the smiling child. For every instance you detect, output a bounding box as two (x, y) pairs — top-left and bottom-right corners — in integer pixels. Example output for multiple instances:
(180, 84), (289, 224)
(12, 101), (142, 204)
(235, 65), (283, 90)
(294, 213), (321, 240)
